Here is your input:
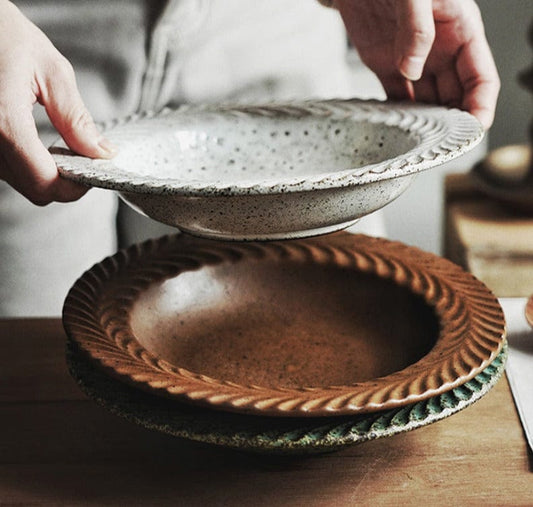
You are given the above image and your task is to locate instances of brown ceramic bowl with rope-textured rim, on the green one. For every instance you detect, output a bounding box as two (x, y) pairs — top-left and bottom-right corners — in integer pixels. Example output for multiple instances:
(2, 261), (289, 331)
(63, 233), (505, 417)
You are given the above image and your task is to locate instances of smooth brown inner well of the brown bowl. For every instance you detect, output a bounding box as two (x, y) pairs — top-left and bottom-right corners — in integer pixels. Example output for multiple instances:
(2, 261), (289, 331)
(130, 258), (439, 388)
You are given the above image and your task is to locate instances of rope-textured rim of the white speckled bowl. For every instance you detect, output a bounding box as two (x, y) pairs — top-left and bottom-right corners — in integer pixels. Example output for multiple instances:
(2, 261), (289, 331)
(50, 99), (485, 197)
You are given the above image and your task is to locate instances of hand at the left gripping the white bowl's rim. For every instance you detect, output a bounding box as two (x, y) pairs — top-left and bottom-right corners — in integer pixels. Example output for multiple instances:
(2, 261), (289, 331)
(0, 0), (114, 205)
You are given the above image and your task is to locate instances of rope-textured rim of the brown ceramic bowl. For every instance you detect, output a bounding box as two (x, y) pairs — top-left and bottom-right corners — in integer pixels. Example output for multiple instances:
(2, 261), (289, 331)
(63, 233), (505, 416)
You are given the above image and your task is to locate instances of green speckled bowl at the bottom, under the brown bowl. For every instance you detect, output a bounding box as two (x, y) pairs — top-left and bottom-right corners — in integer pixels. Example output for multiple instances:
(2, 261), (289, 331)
(67, 342), (507, 455)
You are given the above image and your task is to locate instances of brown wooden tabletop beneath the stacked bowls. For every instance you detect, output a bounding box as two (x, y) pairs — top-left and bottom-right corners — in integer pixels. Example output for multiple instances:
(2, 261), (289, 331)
(0, 319), (533, 506)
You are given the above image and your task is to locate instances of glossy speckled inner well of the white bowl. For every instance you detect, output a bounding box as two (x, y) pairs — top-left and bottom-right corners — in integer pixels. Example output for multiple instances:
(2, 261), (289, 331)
(113, 116), (417, 185)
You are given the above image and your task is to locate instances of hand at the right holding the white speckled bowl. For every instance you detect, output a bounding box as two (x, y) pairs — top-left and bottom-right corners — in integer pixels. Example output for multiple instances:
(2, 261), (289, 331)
(334, 0), (500, 129)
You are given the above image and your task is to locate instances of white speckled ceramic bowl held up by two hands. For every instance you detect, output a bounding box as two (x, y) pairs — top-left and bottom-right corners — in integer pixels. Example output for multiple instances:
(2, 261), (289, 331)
(51, 100), (483, 240)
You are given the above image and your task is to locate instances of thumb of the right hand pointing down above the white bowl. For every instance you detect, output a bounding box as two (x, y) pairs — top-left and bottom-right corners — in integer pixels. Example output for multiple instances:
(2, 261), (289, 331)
(395, 0), (435, 81)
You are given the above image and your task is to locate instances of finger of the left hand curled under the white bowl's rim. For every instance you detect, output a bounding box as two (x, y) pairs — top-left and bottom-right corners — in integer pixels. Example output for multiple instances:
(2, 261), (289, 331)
(0, 102), (88, 206)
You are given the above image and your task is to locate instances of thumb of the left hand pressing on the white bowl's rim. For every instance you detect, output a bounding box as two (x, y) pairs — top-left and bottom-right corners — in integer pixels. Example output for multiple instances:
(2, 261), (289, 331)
(37, 57), (117, 158)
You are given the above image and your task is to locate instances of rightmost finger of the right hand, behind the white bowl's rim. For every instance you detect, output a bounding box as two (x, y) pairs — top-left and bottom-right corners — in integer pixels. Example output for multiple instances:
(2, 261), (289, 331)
(457, 36), (500, 129)
